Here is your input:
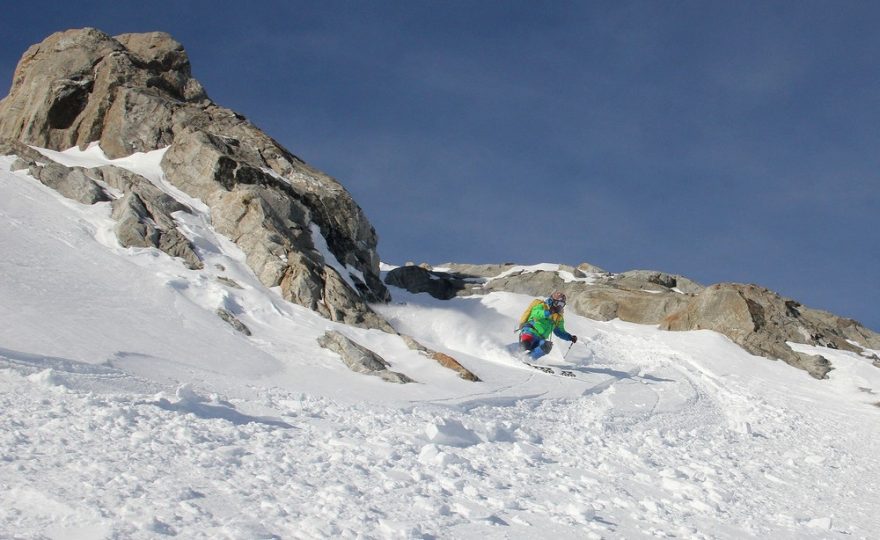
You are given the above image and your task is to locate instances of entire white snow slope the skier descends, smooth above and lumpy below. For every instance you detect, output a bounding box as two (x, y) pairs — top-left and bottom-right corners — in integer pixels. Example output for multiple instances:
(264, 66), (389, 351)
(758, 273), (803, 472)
(0, 148), (880, 539)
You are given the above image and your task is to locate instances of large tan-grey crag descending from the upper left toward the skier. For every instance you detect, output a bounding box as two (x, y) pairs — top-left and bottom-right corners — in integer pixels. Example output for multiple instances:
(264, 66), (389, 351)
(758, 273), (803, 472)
(0, 28), (390, 330)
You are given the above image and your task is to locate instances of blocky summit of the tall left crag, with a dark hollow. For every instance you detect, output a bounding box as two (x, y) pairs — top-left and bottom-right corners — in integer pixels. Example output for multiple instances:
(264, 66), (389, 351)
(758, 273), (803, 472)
(0, 28), (206, 157)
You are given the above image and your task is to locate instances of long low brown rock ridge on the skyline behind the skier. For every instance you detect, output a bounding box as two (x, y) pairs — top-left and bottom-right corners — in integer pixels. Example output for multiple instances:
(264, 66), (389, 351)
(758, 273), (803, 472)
(386, 263), (880, 379)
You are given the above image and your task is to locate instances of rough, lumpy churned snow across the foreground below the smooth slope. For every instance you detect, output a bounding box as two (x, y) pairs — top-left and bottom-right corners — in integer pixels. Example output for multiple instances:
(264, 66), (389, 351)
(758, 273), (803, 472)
(0, 340), (877, 538)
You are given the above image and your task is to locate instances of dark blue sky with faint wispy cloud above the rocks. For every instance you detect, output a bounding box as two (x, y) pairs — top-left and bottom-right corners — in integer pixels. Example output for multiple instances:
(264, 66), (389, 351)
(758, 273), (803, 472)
(0, 0), (880, 330)
